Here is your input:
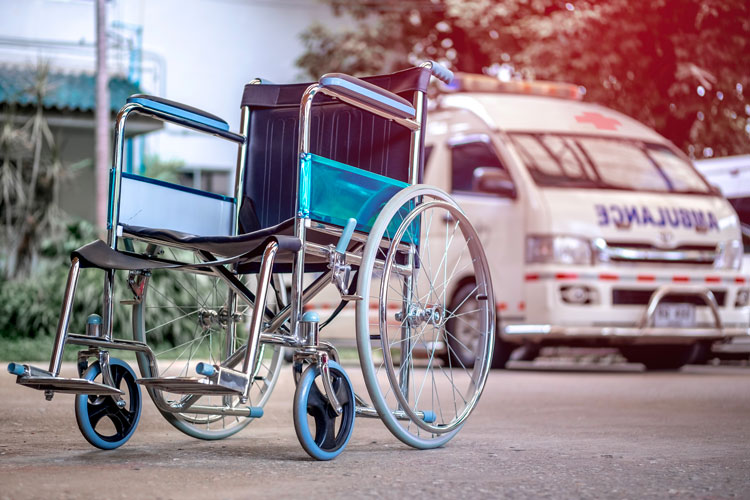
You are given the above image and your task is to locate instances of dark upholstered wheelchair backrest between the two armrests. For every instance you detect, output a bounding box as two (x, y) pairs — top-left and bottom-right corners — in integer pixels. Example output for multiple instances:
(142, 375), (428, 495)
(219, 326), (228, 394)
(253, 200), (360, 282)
(239, 68), (430, 233)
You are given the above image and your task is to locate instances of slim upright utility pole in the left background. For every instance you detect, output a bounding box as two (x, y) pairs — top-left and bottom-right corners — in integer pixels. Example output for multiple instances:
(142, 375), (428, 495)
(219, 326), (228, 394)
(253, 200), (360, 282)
(94, 0), (110, 229)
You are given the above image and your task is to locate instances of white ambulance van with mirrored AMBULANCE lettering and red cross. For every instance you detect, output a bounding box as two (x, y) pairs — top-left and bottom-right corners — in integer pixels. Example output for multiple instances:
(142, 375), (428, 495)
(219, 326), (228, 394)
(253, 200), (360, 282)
(424, 74), (750, 370)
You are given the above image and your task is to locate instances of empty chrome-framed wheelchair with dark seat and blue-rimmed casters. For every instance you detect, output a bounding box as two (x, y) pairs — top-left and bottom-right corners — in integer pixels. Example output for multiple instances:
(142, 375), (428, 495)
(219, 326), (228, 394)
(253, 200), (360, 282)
(8, 61), (495, 460)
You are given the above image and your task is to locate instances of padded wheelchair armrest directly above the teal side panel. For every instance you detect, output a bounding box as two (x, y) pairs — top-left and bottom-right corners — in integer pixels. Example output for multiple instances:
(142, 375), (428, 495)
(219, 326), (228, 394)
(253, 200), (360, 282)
(319, 73), (417, 120)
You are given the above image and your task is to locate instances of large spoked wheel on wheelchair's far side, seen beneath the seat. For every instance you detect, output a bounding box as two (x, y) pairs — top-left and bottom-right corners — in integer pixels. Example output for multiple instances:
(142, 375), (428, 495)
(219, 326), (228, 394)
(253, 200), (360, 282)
(131, 245), (283, 440)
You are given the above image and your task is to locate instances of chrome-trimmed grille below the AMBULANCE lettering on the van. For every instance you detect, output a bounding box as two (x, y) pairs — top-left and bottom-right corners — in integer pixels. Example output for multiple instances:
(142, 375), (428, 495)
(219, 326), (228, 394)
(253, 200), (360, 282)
(596, 240), (718, 266)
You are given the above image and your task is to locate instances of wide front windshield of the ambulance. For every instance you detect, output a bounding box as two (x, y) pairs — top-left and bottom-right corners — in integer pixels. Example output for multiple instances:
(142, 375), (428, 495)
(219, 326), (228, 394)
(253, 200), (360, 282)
(511, 133), (712, 194)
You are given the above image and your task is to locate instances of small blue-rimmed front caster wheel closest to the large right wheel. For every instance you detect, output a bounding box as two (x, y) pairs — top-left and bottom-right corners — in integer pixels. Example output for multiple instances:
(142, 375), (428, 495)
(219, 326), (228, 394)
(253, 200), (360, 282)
(294, 361), (355, 460)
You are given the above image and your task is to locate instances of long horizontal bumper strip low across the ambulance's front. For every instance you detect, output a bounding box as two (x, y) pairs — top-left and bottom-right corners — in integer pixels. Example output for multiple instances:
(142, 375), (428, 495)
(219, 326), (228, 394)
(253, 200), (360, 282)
(502, 325), (750, 345)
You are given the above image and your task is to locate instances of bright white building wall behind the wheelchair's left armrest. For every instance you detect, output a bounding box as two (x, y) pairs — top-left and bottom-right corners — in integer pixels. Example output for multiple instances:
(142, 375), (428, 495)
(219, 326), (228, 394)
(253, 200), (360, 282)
(0, 0), (342, 199)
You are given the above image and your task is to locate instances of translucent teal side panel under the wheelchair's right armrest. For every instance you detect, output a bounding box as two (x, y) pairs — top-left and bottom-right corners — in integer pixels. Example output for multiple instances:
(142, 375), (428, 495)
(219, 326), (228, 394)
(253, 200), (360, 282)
(306, 155), (419, 243)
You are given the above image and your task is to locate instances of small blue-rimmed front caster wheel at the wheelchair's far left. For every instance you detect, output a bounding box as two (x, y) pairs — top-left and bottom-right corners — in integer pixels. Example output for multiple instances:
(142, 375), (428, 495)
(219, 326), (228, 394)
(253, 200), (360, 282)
(75, 358), (141, 450)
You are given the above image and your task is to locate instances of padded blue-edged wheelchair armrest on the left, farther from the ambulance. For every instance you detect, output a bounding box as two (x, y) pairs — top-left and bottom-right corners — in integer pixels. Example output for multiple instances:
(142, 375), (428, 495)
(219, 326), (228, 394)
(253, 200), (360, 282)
(127, 94), (241, 142)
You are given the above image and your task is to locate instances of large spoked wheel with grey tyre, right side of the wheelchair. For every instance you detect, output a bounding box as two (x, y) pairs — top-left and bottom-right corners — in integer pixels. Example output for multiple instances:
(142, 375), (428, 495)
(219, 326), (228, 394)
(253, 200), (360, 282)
(356, 186), (495, 448)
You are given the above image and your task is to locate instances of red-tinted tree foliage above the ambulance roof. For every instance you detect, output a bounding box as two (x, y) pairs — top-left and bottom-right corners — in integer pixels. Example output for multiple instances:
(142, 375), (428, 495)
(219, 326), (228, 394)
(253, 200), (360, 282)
(297, 0), (750, 158)
